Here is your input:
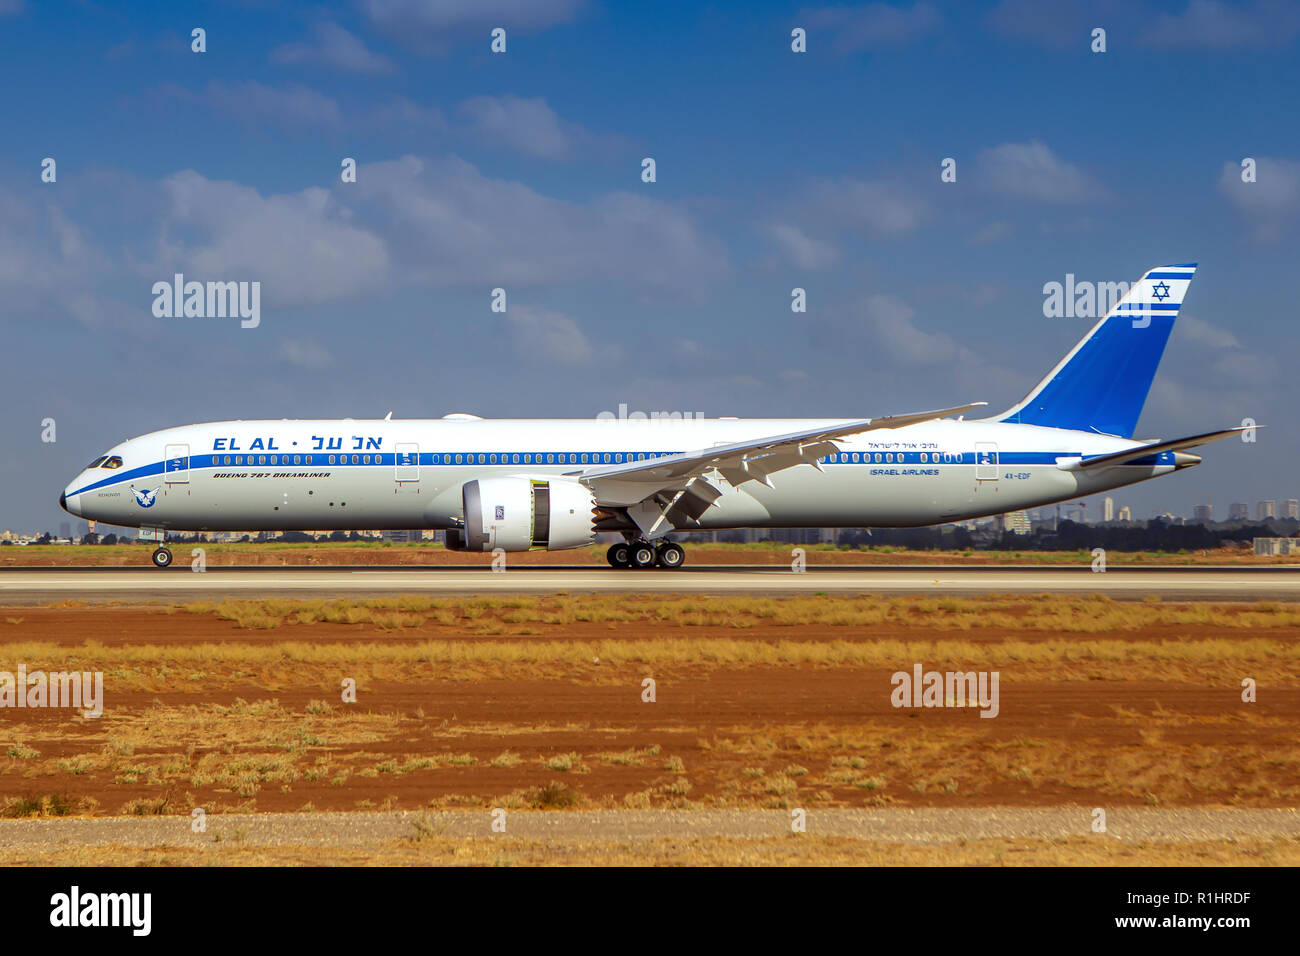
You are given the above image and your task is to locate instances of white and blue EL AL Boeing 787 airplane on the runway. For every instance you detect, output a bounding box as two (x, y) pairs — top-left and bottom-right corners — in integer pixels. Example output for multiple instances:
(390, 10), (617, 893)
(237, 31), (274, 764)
(59, 263), (1244, 568)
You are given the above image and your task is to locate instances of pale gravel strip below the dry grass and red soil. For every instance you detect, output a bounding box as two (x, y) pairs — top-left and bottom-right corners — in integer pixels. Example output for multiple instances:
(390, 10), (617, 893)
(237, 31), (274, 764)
(0, 806), (1300, 852)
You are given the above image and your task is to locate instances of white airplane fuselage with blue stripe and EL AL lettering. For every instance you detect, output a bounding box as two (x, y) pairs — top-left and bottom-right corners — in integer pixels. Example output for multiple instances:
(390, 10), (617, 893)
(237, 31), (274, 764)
(65, 419), (1195, 541)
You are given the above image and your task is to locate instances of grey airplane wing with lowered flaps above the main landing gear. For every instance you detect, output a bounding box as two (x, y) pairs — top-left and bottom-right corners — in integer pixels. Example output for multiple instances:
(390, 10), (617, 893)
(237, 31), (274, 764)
(576, 402), (987, 537)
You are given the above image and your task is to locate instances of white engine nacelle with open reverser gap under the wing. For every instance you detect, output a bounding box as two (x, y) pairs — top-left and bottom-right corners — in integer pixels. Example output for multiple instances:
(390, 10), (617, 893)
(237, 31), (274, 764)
(458, 477), (595, 551)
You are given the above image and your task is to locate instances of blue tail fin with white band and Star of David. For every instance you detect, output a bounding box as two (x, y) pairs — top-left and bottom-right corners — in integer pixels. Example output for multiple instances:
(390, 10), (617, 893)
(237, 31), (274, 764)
(993, 263), (1196, 438)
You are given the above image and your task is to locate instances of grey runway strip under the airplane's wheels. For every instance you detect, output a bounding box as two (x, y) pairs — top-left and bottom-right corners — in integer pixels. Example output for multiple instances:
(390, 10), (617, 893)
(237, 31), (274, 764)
(0, 564), (1300, 604)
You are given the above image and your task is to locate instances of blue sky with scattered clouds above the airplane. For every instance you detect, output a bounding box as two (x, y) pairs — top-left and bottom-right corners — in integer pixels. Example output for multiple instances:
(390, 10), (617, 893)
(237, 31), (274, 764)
(0, 0), (1300, 529)
